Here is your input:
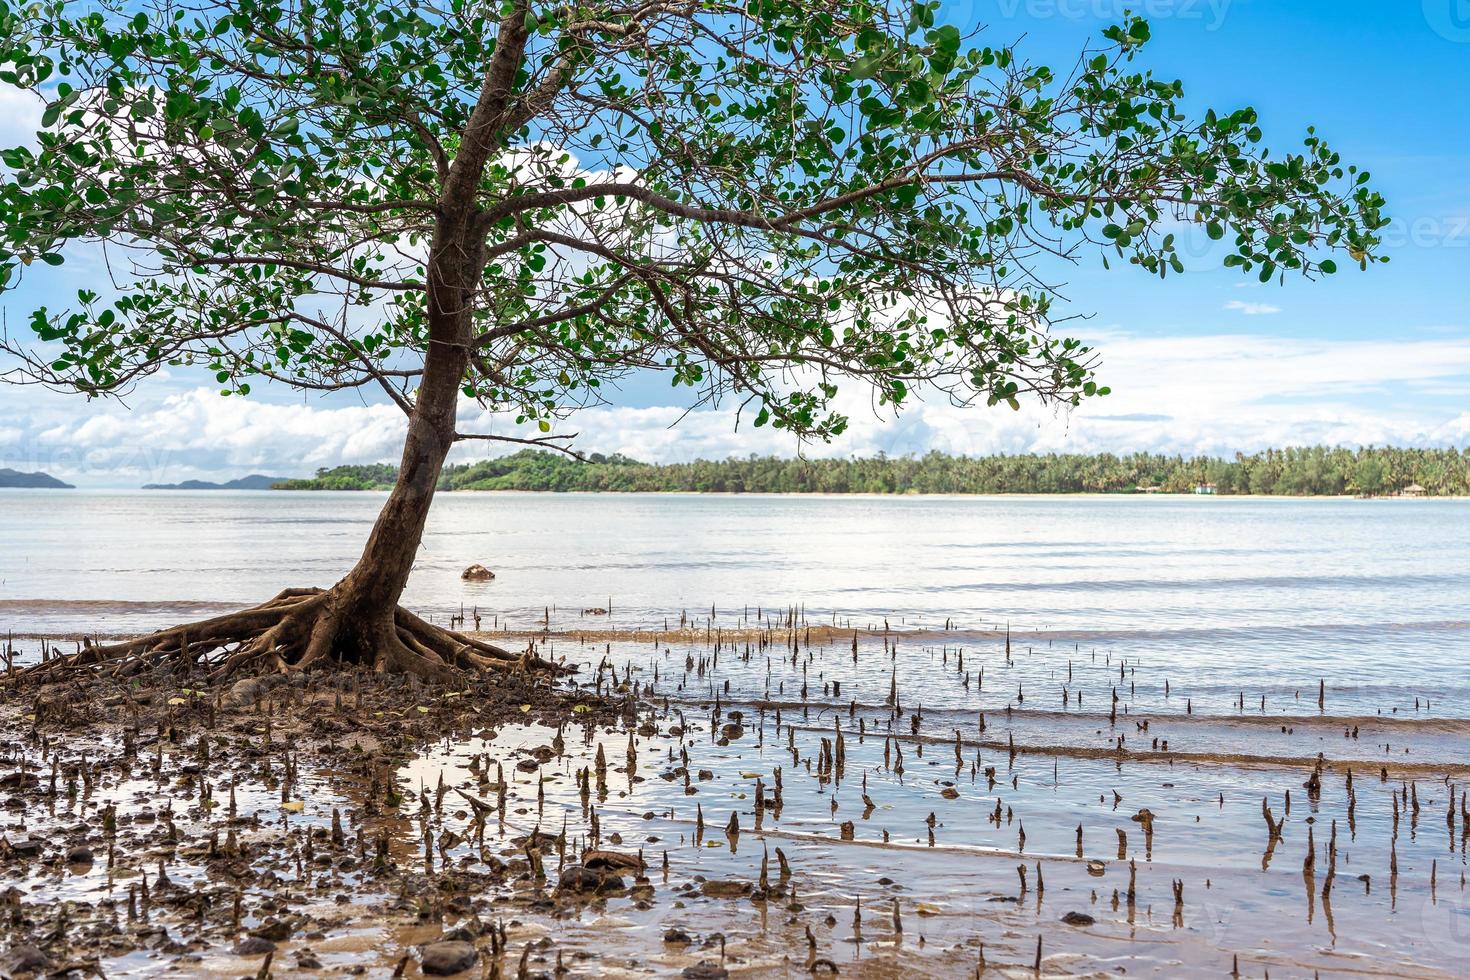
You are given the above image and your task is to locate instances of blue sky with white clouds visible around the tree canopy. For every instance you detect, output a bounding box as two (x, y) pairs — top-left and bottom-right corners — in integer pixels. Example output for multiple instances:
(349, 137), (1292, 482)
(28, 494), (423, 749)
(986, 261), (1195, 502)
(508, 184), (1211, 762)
(0, 0), (1470, 486)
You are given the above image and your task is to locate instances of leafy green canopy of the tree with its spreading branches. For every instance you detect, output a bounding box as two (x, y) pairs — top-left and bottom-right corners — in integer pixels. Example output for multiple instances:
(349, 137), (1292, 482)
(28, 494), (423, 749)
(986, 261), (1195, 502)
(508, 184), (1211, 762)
(0, 0), (1385, 441)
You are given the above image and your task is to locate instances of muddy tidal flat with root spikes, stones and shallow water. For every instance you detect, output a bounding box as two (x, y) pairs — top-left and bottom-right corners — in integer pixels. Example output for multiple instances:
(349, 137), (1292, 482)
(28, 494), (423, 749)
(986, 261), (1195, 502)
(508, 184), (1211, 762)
(0, 605), (1470, 977)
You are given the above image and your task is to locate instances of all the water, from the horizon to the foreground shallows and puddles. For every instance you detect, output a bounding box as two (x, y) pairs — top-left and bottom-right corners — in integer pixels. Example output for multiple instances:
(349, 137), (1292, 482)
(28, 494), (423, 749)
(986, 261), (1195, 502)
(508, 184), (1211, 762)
(0, 494), (1470, 977)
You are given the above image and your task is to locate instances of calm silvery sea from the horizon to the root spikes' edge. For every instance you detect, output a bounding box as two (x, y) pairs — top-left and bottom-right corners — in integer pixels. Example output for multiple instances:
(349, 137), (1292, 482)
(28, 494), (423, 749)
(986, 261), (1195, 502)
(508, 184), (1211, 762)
(0, 491), (1470, 717)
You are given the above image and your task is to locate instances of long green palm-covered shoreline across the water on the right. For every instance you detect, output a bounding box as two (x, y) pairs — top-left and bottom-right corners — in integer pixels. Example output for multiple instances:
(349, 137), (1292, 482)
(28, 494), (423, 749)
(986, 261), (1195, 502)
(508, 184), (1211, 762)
(276, 447), (1470, 497)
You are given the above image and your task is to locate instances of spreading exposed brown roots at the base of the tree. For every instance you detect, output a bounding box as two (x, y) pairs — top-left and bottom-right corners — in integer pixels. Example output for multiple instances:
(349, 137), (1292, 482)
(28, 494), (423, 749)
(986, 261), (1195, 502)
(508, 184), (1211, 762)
(4, 589), (569, 683)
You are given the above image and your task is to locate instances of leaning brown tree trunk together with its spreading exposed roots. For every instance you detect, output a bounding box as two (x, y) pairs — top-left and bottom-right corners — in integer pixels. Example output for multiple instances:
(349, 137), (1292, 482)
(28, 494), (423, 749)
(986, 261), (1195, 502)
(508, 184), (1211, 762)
(4, 7), (572, 680)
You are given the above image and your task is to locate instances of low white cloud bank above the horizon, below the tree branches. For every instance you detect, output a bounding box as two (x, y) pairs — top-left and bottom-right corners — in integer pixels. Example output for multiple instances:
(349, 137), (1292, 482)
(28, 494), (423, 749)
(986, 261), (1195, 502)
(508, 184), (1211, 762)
(0, 331), (1470, 486)
